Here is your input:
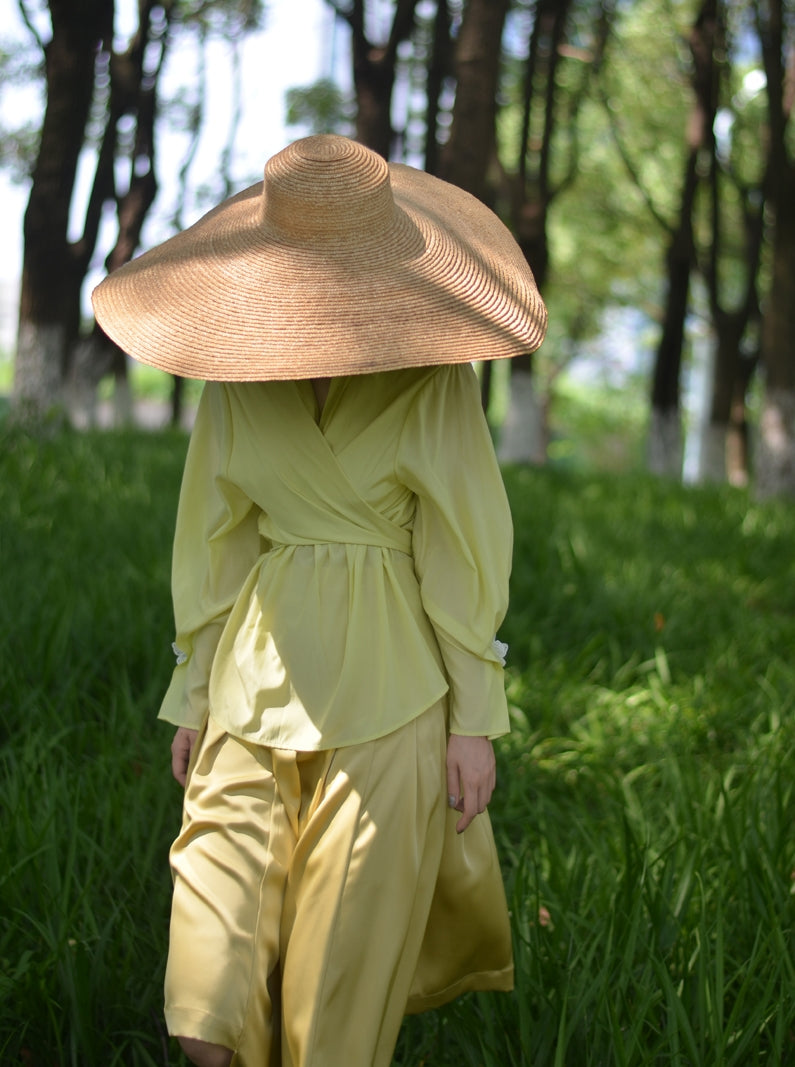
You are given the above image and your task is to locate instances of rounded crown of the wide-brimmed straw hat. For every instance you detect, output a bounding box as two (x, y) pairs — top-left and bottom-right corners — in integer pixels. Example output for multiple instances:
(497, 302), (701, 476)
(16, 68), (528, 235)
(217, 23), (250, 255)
(263, 133), (396, 244)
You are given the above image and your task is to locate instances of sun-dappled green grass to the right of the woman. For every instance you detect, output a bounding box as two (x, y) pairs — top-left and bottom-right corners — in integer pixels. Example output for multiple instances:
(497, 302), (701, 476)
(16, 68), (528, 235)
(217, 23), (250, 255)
(392, 468), (795, 1067)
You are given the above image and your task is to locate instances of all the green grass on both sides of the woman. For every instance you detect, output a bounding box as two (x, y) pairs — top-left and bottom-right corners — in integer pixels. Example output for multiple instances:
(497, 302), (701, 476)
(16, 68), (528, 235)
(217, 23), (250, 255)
(0, 420), (795, 1067)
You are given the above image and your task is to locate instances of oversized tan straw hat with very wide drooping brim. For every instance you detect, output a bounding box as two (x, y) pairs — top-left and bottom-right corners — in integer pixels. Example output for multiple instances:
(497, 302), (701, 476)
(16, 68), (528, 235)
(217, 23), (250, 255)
(93, 134), (546, 381)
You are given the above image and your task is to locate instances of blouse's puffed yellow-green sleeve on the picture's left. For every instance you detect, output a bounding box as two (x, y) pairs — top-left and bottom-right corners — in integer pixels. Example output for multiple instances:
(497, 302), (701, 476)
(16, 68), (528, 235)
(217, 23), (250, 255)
(159, 383), (261, 729)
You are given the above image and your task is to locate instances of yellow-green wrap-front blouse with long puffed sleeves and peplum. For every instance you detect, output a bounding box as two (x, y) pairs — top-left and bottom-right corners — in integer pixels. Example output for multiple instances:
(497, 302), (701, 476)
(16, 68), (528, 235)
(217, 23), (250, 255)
(160, 364), (512, 750)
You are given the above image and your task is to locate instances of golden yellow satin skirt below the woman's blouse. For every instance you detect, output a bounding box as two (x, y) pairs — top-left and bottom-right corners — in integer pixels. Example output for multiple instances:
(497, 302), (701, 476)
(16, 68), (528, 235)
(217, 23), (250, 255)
(165, 703), (512, 1067)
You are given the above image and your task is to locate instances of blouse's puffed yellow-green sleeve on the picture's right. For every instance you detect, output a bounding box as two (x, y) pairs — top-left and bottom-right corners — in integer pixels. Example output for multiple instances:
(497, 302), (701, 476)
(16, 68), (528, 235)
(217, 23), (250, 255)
(397, 365), (513, 737)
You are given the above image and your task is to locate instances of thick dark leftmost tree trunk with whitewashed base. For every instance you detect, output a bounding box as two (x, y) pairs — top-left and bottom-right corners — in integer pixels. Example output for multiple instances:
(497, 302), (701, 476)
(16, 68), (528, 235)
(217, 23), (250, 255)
(14, 0), (113, 415)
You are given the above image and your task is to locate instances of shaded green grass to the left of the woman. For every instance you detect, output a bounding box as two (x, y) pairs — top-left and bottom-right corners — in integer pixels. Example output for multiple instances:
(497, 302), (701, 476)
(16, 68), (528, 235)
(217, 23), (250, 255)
(0, 422), (185, 1067)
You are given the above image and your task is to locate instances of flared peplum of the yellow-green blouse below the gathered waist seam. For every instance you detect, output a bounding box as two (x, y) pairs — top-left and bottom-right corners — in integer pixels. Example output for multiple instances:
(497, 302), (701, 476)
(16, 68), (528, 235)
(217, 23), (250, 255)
(209, 539), (448, 750)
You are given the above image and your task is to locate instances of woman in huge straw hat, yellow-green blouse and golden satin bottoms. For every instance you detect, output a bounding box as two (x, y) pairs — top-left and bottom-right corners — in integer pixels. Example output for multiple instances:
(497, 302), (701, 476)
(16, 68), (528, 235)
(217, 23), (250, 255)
(94, 136), (546, 1067)
